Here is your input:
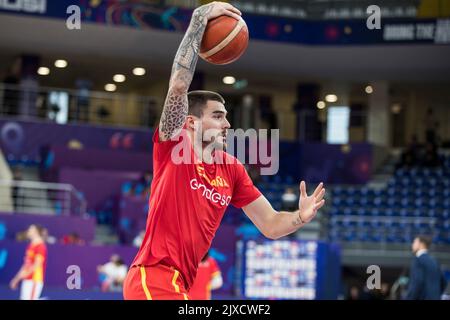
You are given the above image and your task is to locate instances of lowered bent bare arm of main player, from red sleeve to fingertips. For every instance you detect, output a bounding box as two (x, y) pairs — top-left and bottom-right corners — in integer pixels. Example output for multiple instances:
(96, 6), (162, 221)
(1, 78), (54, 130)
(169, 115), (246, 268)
(242, 181), (325, 239)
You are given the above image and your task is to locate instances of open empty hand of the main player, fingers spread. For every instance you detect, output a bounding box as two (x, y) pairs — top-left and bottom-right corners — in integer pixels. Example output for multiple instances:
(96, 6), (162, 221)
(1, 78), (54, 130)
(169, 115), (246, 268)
(298, 181), (325, 223)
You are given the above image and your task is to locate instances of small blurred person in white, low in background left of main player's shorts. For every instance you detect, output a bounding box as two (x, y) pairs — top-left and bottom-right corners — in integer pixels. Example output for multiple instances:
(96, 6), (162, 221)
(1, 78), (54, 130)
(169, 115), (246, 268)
(97, 254), (128, 292)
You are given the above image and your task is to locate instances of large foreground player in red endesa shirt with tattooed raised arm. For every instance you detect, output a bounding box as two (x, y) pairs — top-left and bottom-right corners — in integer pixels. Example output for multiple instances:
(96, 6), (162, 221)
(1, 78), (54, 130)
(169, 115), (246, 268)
(124, 2), (325, 300)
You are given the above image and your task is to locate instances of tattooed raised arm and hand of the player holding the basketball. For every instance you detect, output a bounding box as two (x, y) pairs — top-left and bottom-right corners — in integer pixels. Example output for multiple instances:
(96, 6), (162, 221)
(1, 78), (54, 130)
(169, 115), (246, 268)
(159, 2), (241, 141)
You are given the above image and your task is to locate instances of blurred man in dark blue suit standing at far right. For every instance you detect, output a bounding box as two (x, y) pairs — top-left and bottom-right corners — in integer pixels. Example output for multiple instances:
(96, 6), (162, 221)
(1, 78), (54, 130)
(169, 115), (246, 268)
(407, 235), (447, 300)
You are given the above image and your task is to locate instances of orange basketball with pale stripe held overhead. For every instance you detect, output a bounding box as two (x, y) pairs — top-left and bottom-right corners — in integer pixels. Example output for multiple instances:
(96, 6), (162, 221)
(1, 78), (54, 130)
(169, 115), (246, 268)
(200, 15), (248, 64)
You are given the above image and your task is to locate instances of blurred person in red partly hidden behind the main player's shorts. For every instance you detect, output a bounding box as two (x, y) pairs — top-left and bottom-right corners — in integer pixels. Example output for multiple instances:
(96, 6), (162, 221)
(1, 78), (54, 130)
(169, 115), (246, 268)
(189, 253), (223, 300)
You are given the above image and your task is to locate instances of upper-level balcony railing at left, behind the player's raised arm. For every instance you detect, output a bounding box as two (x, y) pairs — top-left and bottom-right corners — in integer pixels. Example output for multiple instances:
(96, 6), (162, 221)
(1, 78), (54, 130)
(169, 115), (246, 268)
(0, 82), (159, 127)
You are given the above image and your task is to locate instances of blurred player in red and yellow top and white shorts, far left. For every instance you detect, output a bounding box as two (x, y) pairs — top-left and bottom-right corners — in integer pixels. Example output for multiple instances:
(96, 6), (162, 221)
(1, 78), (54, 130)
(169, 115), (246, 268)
(9, 224), (47, 300)
